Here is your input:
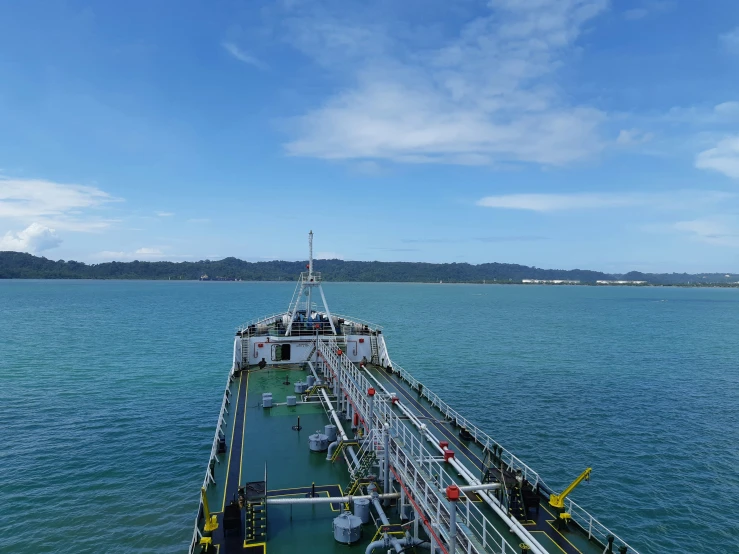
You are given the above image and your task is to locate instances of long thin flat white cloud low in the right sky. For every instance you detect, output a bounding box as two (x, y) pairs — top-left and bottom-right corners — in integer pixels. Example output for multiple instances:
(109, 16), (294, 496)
(477, 190), (734, 212)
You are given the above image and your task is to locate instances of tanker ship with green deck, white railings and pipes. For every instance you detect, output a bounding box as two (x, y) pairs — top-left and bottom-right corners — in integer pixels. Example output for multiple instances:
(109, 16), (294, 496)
(189, 231), (637, 554)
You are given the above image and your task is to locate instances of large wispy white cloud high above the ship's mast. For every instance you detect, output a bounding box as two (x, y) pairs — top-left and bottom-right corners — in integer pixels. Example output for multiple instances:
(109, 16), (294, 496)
(286, 0), (607, 165)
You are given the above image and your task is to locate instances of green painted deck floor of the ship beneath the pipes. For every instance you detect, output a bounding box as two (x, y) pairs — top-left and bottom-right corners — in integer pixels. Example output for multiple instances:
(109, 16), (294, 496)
(195, 358), (604, 554)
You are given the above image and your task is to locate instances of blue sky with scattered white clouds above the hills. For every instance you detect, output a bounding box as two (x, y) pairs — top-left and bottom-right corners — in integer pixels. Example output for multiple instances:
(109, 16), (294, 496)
(0, 0), (739, 272)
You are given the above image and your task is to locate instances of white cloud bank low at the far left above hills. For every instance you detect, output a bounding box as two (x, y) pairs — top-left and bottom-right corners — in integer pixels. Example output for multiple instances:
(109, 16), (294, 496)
(0, 176), (120, 231)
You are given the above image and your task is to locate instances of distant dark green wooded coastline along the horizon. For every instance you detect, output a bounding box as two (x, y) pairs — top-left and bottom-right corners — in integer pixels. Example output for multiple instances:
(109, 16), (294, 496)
(0, 252), (739, 287)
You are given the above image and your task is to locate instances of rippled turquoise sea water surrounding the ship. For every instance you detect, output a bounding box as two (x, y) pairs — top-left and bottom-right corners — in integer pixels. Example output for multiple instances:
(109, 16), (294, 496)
(0, 281), (739, 553)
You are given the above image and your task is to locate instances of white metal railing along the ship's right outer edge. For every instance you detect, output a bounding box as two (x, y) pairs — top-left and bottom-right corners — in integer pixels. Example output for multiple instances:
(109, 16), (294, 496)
(384, 354), (639, 554)
